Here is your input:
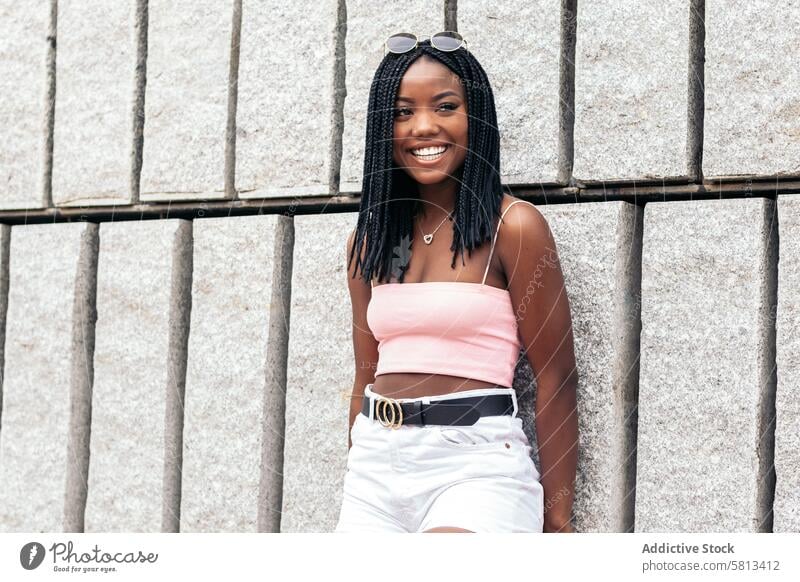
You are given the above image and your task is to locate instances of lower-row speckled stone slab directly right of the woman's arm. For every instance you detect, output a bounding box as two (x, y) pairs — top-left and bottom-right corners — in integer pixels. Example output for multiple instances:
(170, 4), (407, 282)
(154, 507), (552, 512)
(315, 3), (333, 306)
(532, 202), (642, 532)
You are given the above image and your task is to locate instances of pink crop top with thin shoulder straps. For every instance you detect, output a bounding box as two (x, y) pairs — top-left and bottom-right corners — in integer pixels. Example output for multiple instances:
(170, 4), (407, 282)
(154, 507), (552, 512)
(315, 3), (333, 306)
(367, 200), (530, 387)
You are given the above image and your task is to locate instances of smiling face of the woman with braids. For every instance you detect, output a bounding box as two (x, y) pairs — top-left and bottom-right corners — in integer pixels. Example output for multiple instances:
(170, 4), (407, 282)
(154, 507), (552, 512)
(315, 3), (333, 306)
(393, 57), (468, 184)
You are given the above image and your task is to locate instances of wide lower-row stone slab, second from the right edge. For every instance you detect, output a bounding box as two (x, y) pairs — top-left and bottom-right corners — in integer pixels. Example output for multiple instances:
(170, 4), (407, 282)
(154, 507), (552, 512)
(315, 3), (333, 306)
(636, 198), (775, 532)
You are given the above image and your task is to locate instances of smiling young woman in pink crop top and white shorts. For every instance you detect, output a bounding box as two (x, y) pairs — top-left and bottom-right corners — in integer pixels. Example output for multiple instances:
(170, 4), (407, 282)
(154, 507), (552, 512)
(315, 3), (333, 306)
(336, 32), (578, 532)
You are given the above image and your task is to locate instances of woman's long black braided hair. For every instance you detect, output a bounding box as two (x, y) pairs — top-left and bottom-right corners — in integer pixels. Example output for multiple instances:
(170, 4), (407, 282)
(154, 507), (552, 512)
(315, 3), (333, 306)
(347, 40), (503, 283)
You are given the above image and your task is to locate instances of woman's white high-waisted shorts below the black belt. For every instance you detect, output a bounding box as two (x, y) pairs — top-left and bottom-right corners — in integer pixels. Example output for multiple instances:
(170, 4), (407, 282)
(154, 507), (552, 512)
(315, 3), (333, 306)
(335, 384), (544, 533)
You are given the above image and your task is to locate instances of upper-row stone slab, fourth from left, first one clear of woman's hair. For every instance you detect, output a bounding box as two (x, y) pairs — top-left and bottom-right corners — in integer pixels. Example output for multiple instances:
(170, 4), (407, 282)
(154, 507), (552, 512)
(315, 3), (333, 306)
(236, 0), (340, 198)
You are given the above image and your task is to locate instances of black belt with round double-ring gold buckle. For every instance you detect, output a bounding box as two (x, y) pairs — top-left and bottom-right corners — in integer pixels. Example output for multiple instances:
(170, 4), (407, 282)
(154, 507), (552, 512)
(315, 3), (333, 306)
(361, 394), (514, 428)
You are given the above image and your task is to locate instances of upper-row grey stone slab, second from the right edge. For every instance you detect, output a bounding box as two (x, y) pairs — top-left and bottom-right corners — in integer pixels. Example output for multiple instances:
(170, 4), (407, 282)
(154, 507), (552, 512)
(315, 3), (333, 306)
(576, 0), (689, 181)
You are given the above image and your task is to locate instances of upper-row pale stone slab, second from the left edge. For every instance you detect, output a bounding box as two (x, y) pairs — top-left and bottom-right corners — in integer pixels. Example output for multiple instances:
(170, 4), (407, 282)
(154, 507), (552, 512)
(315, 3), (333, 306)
(53, 0), (136, 206)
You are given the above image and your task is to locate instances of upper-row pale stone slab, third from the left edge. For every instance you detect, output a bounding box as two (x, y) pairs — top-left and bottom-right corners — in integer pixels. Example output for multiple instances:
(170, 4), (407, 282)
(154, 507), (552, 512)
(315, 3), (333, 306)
(140, 0), (233, 201)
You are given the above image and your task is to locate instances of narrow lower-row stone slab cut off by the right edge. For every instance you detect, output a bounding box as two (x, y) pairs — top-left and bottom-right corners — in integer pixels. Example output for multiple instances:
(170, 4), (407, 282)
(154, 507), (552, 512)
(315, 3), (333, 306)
(772, 196), (800, 533)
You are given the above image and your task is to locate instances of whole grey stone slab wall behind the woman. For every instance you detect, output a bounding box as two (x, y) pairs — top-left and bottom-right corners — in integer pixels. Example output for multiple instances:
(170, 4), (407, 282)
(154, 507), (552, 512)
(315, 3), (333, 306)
(0, 0), (800, 532)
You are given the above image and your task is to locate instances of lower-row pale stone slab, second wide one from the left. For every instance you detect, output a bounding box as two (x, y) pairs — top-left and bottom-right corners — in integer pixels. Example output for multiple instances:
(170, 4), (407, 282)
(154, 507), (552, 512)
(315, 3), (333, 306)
(86, 220), (189, 532)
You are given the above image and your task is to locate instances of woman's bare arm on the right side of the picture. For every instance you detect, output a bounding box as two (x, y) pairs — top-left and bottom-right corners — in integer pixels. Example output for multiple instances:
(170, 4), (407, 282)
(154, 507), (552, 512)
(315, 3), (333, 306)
(496, 203), (578, 532)
